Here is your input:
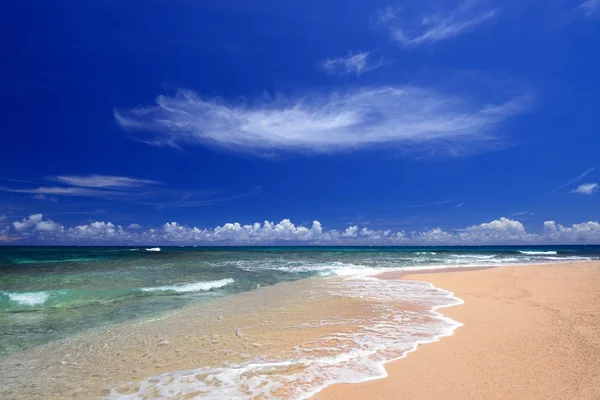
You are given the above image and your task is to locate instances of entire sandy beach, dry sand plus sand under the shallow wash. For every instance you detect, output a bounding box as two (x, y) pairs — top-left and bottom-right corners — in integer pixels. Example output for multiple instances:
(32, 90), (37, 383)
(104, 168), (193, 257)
(0, 261), (600, 399)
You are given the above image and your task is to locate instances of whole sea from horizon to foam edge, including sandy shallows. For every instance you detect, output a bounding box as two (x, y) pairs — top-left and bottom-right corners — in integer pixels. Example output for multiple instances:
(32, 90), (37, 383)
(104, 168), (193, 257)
(0, 246), (600, 399)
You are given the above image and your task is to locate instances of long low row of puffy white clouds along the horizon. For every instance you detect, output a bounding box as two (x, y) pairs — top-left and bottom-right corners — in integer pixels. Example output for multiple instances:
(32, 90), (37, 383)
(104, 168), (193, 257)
(7, 214), (600, 245)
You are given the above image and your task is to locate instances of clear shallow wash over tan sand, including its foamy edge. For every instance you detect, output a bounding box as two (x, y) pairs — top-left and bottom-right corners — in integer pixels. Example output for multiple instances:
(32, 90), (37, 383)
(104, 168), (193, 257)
(0, 278), (456, 399)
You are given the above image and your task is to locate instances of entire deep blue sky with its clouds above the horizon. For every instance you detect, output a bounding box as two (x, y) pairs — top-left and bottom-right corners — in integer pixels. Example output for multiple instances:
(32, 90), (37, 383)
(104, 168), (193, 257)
(0, 0), (600, 244)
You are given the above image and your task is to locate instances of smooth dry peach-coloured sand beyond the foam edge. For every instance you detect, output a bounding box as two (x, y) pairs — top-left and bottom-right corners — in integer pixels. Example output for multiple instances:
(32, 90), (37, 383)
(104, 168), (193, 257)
(316, 262), (600, 400)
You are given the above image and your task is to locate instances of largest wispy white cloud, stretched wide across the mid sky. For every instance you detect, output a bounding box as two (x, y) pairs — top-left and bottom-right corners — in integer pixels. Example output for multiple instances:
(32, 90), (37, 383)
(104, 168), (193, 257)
(115, 86), (527, 155)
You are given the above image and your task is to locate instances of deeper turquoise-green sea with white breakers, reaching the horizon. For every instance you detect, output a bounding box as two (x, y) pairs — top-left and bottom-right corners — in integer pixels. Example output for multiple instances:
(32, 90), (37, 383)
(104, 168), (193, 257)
(0, 246), (600, 356)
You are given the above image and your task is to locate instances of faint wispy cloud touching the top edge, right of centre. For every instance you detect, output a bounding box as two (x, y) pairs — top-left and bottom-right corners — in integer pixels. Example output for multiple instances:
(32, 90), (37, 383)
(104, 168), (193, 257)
(376, 0), (498, 47)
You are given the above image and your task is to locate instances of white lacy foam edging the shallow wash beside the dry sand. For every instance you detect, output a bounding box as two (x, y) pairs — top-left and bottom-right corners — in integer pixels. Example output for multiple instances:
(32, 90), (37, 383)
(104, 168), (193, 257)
(109, 272), (462, 399)
